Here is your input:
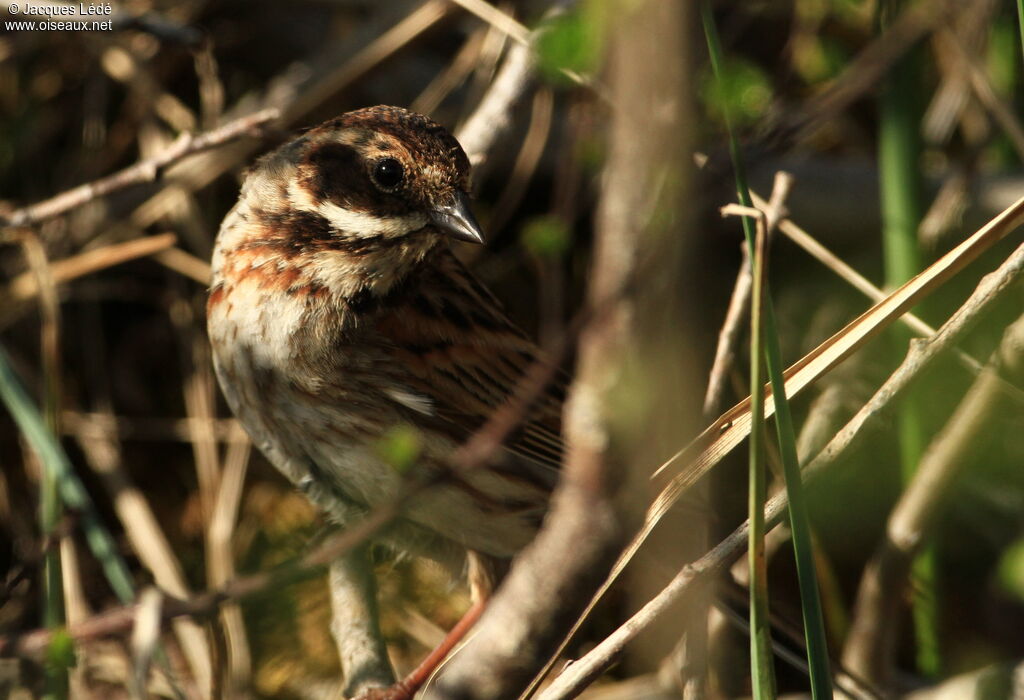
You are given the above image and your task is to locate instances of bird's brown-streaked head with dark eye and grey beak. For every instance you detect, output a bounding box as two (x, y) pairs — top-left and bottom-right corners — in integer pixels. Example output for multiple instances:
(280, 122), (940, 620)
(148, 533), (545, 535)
(253, 106), (483, 251)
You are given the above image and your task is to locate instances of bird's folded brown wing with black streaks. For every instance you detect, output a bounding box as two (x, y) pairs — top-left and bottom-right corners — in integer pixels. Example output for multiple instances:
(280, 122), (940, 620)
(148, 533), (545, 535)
(376, 251), (564, 488)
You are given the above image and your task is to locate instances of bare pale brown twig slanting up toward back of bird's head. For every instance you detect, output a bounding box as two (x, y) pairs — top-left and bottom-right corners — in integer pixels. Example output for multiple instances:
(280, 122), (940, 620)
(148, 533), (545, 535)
(0, 110), (280, 226)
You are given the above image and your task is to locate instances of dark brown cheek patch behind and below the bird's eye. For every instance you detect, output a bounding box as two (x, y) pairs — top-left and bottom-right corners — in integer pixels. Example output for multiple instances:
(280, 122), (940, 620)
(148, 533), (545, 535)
(300, 143), (409, 216)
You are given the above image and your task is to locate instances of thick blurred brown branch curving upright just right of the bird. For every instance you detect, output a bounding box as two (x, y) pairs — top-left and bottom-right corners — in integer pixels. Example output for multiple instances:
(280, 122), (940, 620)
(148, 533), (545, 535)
(426, 0), (688, 699)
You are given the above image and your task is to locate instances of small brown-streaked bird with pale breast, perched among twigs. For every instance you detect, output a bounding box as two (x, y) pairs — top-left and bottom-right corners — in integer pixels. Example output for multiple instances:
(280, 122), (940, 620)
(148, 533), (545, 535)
(207, 105), (564, 697)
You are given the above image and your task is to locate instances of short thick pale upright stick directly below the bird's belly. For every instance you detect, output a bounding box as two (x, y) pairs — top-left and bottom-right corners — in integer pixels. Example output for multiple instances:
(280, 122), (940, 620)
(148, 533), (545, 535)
(330, 546), (394, 697)
